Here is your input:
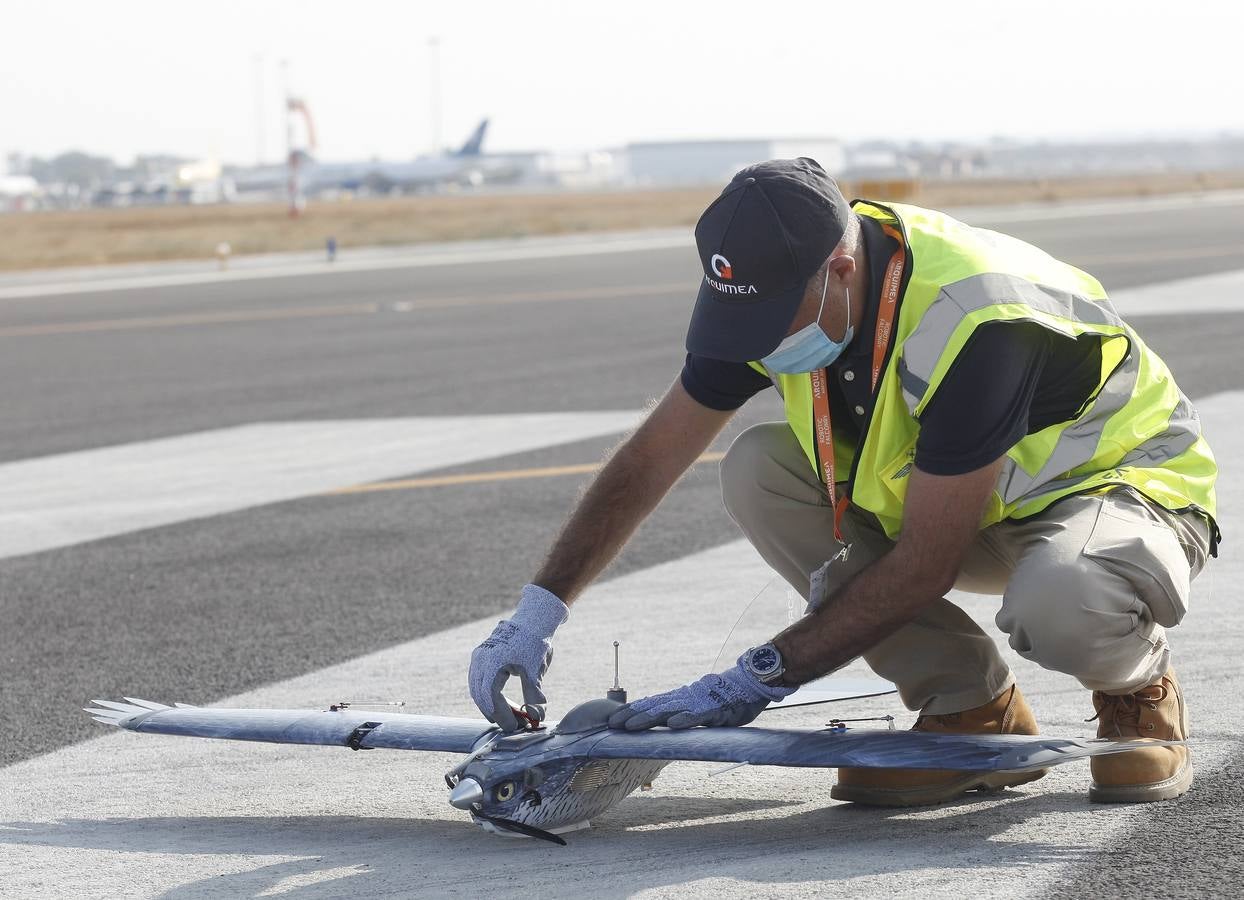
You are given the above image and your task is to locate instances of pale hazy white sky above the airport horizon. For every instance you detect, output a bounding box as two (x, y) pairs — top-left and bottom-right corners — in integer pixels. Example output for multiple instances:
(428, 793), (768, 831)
(0, 0), (1244, 162)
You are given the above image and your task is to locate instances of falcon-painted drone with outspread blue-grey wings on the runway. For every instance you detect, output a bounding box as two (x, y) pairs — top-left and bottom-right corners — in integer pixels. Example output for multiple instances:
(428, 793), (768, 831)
(87, 682), (1152, 844)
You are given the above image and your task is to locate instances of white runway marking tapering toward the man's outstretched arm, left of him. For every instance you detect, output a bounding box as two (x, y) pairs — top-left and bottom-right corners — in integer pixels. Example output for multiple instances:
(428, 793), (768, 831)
(0, 411), (639, 559)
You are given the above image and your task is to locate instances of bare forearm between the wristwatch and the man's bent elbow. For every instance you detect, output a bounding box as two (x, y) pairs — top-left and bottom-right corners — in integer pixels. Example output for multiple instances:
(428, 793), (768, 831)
(774, 551), (943, 685)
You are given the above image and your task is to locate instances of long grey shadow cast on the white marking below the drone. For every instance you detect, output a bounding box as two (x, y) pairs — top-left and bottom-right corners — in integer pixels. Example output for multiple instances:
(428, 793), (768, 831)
(7, 792), (1091, 898)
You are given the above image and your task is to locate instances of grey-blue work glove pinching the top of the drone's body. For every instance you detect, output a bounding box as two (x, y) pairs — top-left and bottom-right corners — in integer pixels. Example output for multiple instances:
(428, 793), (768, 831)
(470, 584), (570, 731)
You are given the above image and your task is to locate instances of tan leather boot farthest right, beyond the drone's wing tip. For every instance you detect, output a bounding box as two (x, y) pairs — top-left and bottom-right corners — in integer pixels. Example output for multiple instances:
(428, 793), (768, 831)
(1089, 668), (1192, 803)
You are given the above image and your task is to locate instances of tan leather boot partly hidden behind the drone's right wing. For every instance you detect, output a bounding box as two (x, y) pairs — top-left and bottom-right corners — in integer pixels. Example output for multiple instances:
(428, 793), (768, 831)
(830, 685), (1045, 807)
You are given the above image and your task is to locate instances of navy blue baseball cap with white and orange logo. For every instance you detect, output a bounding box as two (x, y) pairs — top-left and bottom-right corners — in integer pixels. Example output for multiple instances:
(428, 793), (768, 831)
(687, 157), (853, 362)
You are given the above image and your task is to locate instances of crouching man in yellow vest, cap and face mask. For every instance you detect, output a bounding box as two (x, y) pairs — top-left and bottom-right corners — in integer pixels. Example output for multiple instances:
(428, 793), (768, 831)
(470, 159), (1218, 805)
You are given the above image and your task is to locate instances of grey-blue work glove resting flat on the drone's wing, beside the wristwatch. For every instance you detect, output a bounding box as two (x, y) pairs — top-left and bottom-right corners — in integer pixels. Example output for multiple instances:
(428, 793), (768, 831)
(610, 659), (797, 731)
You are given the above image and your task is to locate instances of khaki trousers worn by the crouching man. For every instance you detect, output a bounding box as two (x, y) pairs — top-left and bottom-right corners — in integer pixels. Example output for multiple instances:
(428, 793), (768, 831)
(722, 422), (1209, 715)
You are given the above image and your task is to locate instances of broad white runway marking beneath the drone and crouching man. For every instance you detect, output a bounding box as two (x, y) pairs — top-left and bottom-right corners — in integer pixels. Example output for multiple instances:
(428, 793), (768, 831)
(0, 392), (1244, 899)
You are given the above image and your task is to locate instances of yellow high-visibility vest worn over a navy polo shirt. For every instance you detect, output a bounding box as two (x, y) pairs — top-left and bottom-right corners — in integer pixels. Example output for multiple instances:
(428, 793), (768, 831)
(750, 200), (1218, 538)
